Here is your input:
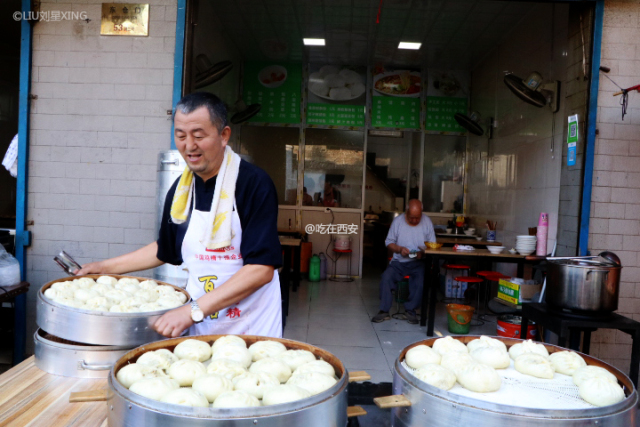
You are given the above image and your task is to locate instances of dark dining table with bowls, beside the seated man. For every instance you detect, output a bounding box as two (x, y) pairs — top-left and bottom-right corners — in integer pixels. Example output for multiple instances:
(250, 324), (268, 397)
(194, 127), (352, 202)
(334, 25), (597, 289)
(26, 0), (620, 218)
(420, 247), (546, 336)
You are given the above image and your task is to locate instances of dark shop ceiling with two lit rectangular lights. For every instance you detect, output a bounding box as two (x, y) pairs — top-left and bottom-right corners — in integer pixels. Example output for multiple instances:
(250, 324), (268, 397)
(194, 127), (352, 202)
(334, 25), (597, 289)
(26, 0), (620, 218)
(204, 0), (536, 69)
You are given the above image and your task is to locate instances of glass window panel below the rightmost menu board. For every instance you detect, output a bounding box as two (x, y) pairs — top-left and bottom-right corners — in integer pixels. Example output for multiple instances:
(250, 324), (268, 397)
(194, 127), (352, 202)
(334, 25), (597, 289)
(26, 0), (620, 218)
(422, 135), (466, 212)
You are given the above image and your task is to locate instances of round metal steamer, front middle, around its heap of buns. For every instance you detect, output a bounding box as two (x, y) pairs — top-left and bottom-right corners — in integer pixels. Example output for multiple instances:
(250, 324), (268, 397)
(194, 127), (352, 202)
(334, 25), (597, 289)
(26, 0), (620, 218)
(107, 335), (348, 427)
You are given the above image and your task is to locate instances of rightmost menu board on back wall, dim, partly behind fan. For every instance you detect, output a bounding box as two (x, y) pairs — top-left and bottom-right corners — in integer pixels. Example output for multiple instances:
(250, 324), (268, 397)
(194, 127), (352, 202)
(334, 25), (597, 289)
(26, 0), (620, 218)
(425, 69), (469, 134)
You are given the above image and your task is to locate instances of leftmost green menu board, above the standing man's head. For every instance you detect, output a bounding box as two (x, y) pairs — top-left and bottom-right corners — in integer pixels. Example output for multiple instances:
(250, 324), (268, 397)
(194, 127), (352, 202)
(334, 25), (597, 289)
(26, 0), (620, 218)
(242, 62), (302, 123)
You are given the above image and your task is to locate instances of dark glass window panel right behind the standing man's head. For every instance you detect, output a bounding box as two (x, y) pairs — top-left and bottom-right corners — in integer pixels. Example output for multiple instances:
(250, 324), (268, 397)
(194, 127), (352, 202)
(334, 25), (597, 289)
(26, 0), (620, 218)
(240, 126), (300, 205)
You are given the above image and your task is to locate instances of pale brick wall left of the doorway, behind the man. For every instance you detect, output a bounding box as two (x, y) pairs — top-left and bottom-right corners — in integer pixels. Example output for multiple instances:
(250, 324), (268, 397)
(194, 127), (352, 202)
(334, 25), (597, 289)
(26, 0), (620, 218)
(27, 0), (177, 352)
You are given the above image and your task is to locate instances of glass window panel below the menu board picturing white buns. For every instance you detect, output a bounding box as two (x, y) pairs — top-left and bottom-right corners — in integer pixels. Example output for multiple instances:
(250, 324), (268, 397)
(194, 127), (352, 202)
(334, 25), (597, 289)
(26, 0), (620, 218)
(302, 129), (364, 209)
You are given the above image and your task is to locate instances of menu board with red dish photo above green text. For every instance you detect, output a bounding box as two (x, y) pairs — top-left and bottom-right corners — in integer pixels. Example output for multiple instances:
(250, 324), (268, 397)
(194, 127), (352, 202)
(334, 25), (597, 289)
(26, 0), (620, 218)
(371, 68), (421, 129)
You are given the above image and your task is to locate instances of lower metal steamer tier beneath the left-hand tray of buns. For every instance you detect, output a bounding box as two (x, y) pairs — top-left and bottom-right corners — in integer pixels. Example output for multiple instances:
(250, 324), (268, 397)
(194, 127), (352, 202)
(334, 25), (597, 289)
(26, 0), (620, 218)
(33, 329), (131, 378)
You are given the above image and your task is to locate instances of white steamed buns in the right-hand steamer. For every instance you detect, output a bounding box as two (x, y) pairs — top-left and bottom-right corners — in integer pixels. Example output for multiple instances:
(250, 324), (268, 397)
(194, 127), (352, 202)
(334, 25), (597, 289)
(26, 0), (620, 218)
(405, 336), (625, 406)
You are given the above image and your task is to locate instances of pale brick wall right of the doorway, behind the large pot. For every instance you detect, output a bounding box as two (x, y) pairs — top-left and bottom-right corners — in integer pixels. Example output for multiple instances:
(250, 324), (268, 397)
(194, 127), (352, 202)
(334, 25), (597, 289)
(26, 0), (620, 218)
(589, 0), (640, 372)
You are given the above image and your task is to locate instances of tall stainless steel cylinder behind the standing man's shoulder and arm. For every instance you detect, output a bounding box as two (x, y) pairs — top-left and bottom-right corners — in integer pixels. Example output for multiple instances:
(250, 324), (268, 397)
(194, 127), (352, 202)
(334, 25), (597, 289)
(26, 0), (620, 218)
(153, 150), (188, 288)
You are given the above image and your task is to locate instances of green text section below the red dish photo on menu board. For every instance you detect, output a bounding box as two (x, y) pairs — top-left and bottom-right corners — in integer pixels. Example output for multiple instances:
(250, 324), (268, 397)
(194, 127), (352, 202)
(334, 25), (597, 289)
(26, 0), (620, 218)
(371, 96), (420, 129)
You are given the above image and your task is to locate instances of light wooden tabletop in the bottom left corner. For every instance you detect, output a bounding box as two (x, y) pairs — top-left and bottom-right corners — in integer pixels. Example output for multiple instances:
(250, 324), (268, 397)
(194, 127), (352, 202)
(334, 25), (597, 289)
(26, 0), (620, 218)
(0, 356), (107, 427)
